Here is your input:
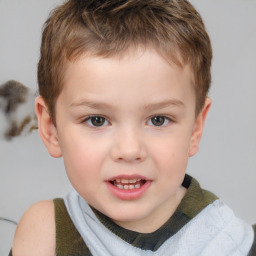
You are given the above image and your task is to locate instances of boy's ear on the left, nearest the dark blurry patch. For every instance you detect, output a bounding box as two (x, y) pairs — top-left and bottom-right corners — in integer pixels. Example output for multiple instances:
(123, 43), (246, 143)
(35, 96), (62, 157)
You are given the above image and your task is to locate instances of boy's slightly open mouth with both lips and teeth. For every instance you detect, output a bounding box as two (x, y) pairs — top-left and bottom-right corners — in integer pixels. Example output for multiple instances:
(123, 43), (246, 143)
(106, 175), (152, 200)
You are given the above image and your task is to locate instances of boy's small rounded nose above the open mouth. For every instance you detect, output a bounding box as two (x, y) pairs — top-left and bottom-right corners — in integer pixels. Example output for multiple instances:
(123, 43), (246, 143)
(111, 128), (146, 162)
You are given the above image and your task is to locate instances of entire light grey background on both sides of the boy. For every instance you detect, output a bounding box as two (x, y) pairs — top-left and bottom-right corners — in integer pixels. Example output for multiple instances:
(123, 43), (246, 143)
(0, 0), (256, 255)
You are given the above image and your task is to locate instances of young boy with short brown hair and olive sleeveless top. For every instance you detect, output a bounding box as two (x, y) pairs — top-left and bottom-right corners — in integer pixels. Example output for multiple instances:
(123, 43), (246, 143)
(9, 0), (255, 256)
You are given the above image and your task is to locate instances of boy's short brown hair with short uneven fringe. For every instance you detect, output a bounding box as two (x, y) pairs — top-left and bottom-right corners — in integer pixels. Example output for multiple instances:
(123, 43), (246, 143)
(38, 0), (212, 121)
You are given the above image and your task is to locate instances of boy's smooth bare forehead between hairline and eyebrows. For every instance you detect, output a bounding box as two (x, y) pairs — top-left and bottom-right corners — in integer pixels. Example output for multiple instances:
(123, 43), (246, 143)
(60, 49), (194, 108)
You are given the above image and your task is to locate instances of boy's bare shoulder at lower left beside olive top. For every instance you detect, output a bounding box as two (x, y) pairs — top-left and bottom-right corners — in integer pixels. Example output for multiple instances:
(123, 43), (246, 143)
(12, 201), (55, 256)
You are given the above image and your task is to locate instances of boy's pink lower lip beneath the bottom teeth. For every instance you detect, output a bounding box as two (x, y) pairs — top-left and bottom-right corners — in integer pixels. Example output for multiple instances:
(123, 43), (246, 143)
(106, 181), (152, 200)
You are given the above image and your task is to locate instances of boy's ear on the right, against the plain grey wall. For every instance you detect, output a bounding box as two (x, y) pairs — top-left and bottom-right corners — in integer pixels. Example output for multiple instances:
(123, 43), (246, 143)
(189, 97), (212, 156)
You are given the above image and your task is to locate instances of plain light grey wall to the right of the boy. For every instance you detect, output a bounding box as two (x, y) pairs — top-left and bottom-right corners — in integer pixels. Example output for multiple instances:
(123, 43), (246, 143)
(188, 0), (256, 223)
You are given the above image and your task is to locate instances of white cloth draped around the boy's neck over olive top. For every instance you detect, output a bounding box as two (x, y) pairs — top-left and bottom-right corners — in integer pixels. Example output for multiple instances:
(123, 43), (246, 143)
(64, 191), (254, 256)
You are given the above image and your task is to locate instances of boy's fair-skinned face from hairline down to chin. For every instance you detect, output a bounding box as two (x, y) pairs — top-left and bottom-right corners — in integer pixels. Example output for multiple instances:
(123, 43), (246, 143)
(38, 47), (208, 232)
